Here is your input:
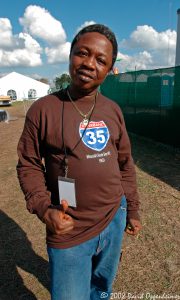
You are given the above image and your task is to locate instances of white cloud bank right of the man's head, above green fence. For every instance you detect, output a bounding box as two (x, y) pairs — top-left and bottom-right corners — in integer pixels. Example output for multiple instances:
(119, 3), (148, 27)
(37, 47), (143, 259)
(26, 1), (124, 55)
(119, 25), (176, 71)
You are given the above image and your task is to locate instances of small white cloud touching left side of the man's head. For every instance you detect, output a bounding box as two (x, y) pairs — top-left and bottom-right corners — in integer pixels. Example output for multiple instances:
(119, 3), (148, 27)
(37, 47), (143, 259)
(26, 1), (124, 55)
(45, 42), (71, 64)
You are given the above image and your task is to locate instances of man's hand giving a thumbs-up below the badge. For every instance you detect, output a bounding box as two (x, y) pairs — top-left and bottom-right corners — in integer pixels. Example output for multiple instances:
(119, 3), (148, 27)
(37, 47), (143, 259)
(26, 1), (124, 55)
(43, 200), (74, 235)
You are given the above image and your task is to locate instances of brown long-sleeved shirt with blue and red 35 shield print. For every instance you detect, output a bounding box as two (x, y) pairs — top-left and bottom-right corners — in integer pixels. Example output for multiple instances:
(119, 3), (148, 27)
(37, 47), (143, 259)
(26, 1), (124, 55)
(17, 91), (139, 248)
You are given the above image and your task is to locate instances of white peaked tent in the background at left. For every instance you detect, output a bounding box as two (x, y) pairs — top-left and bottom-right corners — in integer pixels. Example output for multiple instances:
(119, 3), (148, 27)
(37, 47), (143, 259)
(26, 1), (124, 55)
(0, 72), (50, 100)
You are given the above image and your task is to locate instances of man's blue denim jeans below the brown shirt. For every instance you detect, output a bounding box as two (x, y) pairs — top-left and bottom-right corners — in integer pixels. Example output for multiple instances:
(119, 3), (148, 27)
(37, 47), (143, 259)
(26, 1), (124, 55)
(47, 196), (127, 300)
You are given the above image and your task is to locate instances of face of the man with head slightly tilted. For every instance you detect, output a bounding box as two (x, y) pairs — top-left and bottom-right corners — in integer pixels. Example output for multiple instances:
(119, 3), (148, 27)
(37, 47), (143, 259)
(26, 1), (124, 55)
(69, 32), (113, 91)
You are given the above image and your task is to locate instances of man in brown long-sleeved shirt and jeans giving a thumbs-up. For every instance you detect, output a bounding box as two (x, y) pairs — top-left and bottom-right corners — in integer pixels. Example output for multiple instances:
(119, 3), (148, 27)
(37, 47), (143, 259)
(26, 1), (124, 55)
(17, 24), (141, 300)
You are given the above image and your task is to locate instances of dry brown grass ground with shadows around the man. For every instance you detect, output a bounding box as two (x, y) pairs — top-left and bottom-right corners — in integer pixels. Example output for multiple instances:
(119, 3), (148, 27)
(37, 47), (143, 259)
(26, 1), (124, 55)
(0, 103), (180, 300)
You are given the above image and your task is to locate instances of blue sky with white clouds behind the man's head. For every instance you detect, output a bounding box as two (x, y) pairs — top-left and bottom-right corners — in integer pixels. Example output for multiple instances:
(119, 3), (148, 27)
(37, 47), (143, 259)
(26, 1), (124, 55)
(0, 0), (180, 81)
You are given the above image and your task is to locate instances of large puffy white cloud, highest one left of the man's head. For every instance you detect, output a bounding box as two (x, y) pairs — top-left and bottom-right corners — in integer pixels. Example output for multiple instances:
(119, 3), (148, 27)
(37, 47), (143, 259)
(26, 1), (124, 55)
(19, 5), (66, 44)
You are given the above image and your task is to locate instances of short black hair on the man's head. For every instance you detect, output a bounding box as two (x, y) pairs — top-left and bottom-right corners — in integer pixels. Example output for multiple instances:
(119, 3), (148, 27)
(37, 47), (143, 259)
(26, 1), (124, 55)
(70, 24), (118, 68)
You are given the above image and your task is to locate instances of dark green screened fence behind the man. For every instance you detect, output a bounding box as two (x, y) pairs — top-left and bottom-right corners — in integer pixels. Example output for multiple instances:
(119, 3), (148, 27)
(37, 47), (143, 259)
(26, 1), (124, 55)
(101, 67), (180, 148)
